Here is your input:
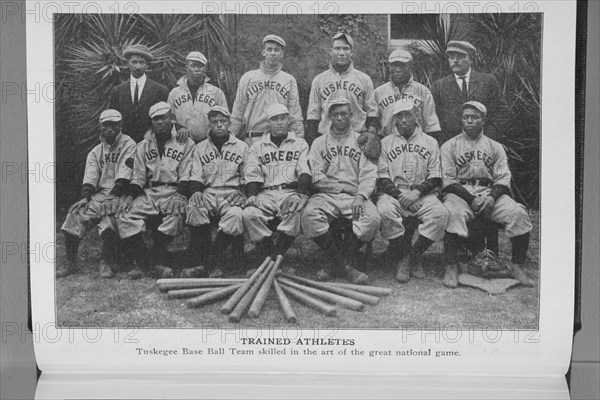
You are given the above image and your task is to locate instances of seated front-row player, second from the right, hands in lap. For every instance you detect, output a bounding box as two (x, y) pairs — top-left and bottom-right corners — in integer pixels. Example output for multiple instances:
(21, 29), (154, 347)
(377, 97), (448, 283)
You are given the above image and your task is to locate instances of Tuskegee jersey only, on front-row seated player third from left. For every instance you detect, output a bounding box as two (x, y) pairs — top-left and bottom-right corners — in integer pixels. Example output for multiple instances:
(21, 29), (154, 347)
(191, 132), (248, 188)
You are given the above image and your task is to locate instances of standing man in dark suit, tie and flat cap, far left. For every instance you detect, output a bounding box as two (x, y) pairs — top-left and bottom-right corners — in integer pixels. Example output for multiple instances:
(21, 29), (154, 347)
(108, 44), (169, 143)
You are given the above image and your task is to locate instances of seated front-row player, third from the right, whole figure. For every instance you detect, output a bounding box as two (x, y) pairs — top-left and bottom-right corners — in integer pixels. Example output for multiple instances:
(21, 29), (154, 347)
(301, 98), (380, 284)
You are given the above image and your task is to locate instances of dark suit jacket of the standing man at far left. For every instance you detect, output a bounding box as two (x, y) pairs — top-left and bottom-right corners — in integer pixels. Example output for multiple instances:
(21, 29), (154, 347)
(109, 76), (169, 143)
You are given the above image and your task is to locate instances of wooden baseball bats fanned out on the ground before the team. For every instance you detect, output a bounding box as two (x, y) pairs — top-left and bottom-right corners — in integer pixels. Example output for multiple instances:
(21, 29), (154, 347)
(156, 256), (392, 323)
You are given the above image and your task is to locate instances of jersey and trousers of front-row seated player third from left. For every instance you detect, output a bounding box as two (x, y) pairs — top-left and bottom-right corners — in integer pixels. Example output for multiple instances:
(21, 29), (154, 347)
(186, 132), (248, 236)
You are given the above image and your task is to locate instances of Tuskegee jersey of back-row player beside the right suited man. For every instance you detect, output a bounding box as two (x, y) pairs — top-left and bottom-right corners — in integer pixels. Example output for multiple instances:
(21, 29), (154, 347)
(375, 78), (442, 136)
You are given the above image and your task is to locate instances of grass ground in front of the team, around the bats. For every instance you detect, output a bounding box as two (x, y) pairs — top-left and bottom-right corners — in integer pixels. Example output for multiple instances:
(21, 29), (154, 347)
(56, 212), (540, 330)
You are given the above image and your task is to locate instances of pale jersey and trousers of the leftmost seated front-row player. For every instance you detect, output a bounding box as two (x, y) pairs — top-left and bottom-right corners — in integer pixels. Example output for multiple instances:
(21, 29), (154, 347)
(61, 133), (136, 238)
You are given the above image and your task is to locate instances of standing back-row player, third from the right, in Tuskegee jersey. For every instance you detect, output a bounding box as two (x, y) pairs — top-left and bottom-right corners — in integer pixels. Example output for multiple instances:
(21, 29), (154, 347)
(306, 32), (378, 144)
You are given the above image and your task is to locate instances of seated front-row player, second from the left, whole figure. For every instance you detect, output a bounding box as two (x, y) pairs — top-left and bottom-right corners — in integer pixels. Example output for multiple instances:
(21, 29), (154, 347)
(117, 102), (194, 279)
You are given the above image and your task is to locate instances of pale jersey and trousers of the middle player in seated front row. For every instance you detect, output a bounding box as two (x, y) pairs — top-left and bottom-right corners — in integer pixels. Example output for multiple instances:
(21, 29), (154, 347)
(243, 131), (310, 242)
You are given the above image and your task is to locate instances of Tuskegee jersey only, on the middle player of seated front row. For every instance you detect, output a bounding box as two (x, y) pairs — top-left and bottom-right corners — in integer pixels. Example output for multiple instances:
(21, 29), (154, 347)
(246, 131), (310, 188)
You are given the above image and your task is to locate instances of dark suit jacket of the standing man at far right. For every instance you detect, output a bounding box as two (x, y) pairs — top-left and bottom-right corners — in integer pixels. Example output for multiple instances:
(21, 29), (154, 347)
(431, 70), (506, 145)
